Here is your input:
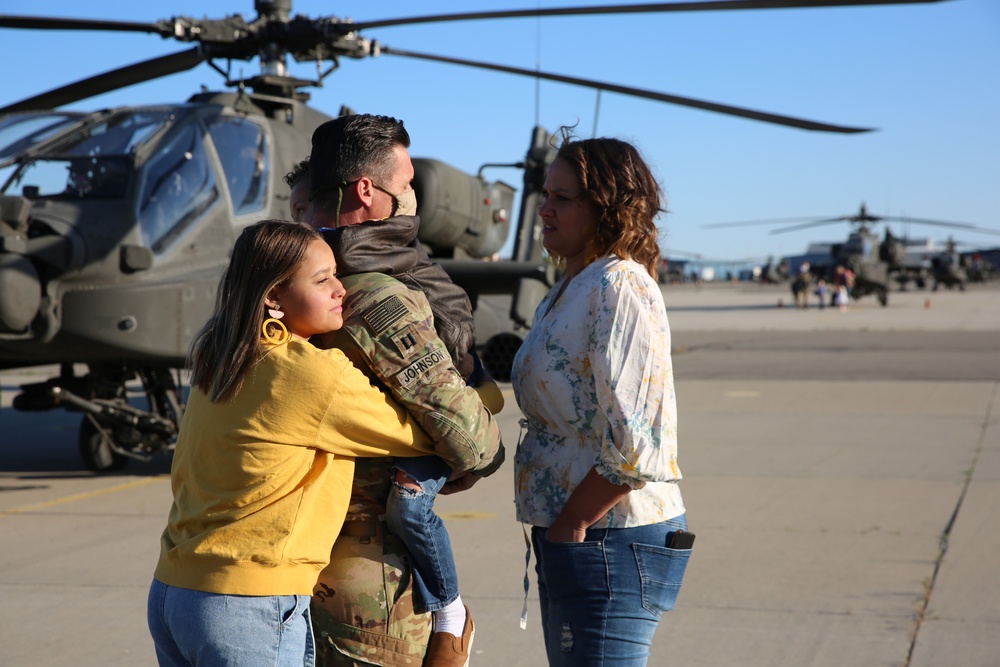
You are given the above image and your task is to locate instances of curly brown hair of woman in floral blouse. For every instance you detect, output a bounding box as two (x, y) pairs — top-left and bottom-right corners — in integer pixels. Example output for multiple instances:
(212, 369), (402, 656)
(556, 128), (667, 280)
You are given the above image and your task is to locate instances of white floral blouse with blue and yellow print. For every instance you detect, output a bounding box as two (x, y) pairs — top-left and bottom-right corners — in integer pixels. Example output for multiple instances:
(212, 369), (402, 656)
(511, 257), (684, 528)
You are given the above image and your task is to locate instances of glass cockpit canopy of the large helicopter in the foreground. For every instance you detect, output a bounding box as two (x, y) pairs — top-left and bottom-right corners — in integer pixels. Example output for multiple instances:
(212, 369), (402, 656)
(0, 106), (270, 252)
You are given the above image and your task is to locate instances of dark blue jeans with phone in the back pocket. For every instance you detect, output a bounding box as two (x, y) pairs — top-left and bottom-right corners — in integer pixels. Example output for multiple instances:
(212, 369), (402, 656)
(531, 515), (691, 667)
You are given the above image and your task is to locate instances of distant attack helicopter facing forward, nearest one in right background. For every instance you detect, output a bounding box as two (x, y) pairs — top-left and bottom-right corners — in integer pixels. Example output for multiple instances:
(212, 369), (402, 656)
(703, 202), (1000, 306)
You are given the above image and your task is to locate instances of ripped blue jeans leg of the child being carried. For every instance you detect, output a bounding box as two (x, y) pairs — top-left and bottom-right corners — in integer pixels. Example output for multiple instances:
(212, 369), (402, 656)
(385, 456), (458, 613)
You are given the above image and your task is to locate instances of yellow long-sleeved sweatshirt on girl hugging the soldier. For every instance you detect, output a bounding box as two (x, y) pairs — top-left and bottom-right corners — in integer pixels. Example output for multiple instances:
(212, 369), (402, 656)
(154, 340), (431, 595)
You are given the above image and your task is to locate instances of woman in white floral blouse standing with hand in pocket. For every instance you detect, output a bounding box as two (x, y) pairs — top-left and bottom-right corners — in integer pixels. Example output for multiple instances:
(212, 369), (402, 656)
(512, 137), (691, 667)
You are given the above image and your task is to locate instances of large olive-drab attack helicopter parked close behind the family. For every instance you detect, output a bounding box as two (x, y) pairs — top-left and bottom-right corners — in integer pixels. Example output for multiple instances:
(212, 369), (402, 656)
(0, 0), (952, 472)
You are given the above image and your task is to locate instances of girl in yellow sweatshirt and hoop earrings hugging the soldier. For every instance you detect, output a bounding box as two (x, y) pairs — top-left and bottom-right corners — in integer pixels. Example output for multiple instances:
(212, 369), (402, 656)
(148, 220), (432, 667)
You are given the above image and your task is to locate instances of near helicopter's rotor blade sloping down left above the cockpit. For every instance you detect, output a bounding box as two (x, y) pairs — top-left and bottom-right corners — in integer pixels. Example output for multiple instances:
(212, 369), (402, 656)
(0, 46), (205, 114)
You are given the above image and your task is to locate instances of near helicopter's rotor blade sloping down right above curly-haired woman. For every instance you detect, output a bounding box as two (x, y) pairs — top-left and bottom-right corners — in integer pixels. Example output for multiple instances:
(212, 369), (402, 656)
(381, 44), (874, 134)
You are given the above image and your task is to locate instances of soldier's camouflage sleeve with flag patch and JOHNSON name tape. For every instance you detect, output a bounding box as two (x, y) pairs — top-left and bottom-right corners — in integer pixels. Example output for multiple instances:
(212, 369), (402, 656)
(313, 273), (504, 476)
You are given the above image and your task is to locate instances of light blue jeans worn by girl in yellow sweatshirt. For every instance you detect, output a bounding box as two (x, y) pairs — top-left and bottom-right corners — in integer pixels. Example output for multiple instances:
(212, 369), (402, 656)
(146, 579), (316, 667)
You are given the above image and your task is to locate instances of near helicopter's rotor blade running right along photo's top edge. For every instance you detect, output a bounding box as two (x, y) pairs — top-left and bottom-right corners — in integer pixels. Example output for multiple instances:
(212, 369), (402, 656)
(350, 0), (943, 30)
